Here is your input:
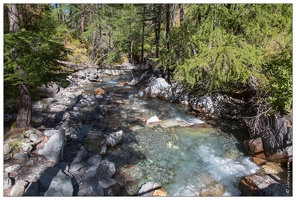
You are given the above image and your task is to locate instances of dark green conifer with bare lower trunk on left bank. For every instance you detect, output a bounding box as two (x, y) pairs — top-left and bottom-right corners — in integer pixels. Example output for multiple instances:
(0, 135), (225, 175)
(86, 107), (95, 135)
(4, 4), (69, 128)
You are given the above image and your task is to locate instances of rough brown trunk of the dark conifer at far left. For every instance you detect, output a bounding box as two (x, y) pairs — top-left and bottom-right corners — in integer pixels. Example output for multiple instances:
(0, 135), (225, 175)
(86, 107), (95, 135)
(8, 4), (32, 128)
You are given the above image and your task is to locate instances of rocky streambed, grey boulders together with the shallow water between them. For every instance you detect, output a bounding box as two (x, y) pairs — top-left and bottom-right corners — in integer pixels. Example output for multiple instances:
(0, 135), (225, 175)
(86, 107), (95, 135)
(3, 68), (291, 196)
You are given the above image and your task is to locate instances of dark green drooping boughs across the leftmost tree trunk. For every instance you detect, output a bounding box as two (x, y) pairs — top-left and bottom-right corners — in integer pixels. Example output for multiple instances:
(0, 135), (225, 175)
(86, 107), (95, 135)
(4, 30), (68, 86)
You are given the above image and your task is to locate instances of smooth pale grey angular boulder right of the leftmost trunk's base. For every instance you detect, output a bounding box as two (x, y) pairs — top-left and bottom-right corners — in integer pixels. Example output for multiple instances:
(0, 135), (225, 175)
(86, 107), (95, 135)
(38, 130), (65, 162)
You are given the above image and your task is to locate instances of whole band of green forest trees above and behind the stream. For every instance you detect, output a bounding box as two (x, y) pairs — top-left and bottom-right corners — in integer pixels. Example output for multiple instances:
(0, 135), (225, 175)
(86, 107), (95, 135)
(3, 4), (293, 130)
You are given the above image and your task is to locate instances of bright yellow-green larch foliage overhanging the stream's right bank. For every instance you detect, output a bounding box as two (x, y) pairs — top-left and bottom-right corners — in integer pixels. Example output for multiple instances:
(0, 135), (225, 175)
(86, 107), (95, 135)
(170, 4), (292, 111)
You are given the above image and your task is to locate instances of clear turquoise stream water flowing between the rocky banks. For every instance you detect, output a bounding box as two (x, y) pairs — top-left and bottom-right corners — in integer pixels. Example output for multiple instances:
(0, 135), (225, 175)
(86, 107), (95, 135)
(84, 72), (259, 196)
